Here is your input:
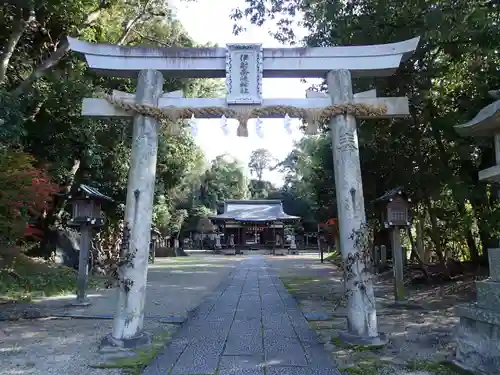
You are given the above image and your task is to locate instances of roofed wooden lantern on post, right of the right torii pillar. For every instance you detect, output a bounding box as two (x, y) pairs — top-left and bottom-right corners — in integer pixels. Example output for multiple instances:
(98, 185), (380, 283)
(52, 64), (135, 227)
(375, 188), (411, 302)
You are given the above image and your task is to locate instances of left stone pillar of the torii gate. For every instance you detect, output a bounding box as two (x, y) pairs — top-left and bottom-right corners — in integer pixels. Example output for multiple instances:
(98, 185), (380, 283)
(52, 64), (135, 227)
(105, 70), (164, 350)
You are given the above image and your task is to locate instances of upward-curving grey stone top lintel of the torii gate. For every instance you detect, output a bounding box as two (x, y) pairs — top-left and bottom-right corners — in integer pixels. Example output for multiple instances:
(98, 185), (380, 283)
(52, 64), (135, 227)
(68, 37), (420, 78)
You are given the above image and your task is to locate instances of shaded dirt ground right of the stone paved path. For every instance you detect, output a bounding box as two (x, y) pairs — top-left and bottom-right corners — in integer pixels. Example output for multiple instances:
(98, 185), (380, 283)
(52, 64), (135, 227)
(268, 254), (474, 375)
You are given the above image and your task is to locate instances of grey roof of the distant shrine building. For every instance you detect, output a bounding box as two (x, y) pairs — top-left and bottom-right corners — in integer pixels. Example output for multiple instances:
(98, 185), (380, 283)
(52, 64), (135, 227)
(210, 199), (300, 222)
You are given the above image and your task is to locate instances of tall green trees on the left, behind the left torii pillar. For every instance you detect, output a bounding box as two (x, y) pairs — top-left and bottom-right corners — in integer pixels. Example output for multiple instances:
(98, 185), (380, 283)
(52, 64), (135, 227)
(0, 0), (225, 262)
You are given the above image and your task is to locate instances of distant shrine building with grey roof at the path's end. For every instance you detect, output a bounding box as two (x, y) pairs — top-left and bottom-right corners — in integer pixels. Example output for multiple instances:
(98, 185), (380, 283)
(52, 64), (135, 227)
(210, 199), (300, 249)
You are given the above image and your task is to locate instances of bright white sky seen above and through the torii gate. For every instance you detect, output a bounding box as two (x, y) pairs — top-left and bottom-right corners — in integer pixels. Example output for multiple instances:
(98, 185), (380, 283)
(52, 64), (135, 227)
(172, 0), (310, 186)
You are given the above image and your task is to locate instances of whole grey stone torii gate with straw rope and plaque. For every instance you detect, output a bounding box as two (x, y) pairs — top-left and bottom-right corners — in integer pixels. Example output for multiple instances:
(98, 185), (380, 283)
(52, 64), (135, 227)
(68, 38), (419, 347)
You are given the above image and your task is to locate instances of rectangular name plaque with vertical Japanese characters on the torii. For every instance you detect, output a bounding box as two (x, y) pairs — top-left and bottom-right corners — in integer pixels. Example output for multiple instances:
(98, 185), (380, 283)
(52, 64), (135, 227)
(226, 44), (263, 104)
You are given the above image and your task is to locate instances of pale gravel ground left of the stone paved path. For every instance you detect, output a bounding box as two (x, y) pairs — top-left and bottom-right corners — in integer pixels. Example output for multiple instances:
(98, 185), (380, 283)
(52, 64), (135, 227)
(0, 253), (242, 375)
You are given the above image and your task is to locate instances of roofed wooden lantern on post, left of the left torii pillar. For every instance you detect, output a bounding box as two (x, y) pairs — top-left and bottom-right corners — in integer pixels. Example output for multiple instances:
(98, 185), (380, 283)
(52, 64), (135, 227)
(68, 185), (113, 306)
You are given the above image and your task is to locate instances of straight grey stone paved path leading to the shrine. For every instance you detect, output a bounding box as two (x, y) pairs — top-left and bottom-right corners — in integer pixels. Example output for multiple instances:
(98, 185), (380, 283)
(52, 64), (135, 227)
(143, 256), (340, 375)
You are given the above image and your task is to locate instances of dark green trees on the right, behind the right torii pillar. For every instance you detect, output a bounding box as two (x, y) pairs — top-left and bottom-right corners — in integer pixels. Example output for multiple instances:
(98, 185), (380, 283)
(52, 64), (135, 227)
(233, 0), (500, 261)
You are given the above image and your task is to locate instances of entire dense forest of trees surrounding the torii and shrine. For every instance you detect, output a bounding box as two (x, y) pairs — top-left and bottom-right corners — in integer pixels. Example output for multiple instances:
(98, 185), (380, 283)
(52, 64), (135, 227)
(0, 0), (500, 276)
